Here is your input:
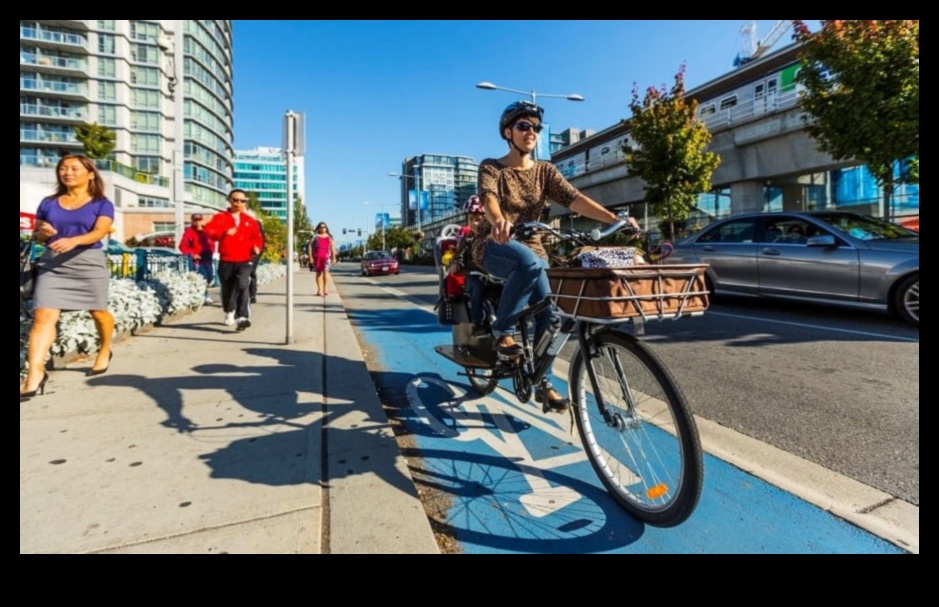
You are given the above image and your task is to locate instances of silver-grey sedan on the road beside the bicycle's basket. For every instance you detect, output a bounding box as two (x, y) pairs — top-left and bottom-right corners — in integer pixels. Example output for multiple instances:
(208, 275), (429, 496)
(669, 211), (919, 326)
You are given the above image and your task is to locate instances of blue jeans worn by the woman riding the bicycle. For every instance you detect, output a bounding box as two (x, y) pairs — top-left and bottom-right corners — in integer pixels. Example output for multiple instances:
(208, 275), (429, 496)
(483, 240), (552, 344)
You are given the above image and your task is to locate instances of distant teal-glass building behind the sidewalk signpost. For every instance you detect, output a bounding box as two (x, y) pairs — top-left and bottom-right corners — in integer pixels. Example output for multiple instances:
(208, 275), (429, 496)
(234, 147), (304, 222)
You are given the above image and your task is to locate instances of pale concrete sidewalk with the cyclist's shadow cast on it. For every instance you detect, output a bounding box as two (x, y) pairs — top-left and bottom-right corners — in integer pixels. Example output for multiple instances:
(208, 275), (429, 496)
(20, 271), (440, 554)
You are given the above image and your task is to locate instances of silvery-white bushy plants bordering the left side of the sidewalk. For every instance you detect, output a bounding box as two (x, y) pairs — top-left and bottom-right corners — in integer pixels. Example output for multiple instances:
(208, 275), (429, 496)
(20, 264), (287, 380)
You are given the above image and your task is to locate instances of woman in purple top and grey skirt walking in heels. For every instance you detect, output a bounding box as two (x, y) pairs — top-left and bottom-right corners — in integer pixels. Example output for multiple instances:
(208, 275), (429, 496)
(20, 154), (114, 401)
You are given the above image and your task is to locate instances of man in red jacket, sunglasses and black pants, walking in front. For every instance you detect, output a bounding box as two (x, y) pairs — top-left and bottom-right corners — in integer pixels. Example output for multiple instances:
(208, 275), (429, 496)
(203, 188), (264, 331)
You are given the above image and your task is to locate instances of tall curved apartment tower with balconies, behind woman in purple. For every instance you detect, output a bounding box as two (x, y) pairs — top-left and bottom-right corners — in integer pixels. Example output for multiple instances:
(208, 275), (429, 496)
(20, 19), (234, 239)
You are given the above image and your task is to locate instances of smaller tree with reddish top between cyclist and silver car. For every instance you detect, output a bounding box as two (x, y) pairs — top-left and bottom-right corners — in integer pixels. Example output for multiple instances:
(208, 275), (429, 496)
(623, 64), (720, 238)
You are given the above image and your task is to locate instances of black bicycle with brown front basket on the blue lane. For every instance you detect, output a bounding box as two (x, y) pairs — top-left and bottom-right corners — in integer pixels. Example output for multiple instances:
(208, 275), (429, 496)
(435, 219), (708, 527)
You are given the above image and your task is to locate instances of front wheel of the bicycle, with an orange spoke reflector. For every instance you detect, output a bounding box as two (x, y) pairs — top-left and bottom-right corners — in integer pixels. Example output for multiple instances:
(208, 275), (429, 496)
(570, 331), (704, 527)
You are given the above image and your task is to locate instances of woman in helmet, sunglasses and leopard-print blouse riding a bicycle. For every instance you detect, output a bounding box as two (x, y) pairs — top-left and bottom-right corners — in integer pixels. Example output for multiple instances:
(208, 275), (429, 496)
(473, 101), (638, 410)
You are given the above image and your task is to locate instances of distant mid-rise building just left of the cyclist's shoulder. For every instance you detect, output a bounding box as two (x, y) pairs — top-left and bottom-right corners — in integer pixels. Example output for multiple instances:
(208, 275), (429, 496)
(401, 154), (479, 227)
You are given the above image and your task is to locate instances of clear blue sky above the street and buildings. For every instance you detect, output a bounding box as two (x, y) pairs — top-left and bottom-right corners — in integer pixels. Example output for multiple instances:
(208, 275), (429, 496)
(234, 20), (817, 243)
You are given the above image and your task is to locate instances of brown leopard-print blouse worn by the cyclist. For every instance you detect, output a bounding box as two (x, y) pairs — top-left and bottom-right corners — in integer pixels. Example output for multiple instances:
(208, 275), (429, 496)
(473, 158), (580, 267)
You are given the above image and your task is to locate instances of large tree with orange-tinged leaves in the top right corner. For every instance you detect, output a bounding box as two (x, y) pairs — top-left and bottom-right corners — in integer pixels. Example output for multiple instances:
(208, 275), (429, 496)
(793, 20), (919, 219)
